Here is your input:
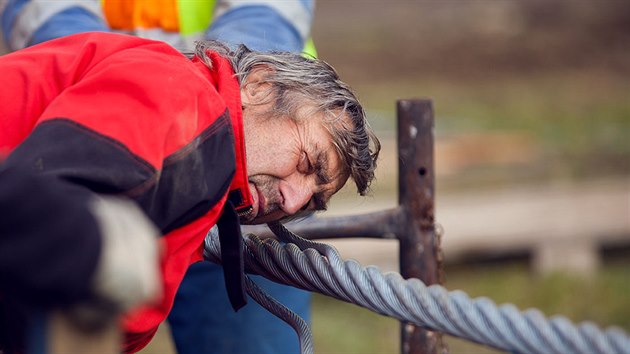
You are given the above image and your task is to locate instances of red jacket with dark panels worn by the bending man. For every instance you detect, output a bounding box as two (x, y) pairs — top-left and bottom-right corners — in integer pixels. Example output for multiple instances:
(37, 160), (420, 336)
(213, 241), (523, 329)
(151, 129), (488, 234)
(0, 33), (252, 351)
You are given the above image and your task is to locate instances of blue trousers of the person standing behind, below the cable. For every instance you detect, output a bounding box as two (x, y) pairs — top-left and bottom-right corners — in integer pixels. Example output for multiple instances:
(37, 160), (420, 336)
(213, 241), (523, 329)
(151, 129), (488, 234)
(168, 262), (311, 354)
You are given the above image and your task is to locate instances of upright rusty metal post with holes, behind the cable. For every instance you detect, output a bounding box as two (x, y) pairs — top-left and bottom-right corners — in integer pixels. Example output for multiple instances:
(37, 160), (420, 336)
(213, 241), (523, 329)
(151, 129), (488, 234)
(397, 100), (439, 354)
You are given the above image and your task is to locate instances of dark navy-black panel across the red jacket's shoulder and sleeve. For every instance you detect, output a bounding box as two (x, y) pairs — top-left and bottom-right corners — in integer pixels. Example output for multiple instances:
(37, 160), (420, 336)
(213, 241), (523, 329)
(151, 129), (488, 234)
(6, 111), (236, 233)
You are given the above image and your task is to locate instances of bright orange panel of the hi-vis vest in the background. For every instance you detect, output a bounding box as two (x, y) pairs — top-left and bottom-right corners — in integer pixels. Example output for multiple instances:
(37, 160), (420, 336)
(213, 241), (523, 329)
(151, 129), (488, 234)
(103, 0), (179, 32)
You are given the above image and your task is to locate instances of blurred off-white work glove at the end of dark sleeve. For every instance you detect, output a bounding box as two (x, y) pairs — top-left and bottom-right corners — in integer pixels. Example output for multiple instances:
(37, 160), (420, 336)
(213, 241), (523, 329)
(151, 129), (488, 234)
(71, 196), (162, 327)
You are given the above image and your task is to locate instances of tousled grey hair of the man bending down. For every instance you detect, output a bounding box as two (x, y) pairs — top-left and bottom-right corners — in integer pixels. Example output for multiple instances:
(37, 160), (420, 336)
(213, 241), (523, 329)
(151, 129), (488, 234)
(195, 41), (381, 195)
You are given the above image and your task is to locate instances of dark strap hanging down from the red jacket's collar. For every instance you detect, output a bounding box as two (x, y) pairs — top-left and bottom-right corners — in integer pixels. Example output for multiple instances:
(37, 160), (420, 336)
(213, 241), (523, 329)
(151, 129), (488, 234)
(217, 201), (247, 311)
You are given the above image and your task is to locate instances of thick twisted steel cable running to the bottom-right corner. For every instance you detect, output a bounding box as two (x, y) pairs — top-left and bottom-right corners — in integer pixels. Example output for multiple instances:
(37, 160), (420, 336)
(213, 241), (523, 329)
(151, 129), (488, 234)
(206, 223), (630, 354)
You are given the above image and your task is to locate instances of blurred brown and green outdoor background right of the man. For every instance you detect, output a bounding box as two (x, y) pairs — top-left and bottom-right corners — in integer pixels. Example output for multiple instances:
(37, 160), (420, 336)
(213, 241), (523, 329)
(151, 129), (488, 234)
(304, 0), (630, 353)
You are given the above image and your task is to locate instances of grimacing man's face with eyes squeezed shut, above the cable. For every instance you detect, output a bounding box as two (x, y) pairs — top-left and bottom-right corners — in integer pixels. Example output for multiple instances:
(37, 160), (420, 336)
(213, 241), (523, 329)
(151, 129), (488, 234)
(242, 98), (348, 224)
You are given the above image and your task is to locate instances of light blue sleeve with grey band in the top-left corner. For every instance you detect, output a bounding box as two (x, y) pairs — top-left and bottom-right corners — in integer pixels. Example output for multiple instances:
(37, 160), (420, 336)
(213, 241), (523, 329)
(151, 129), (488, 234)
(0, 0), (109, 50)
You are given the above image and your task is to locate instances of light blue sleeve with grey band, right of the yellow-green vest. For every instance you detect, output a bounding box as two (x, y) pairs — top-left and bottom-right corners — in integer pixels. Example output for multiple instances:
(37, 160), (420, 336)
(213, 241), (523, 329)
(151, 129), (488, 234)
(206, 0), (314, 52)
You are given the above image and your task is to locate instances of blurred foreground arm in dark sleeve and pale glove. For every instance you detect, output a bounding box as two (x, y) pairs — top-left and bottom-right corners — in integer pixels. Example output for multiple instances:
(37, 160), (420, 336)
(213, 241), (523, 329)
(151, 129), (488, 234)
(0, 165), (159, 310)
